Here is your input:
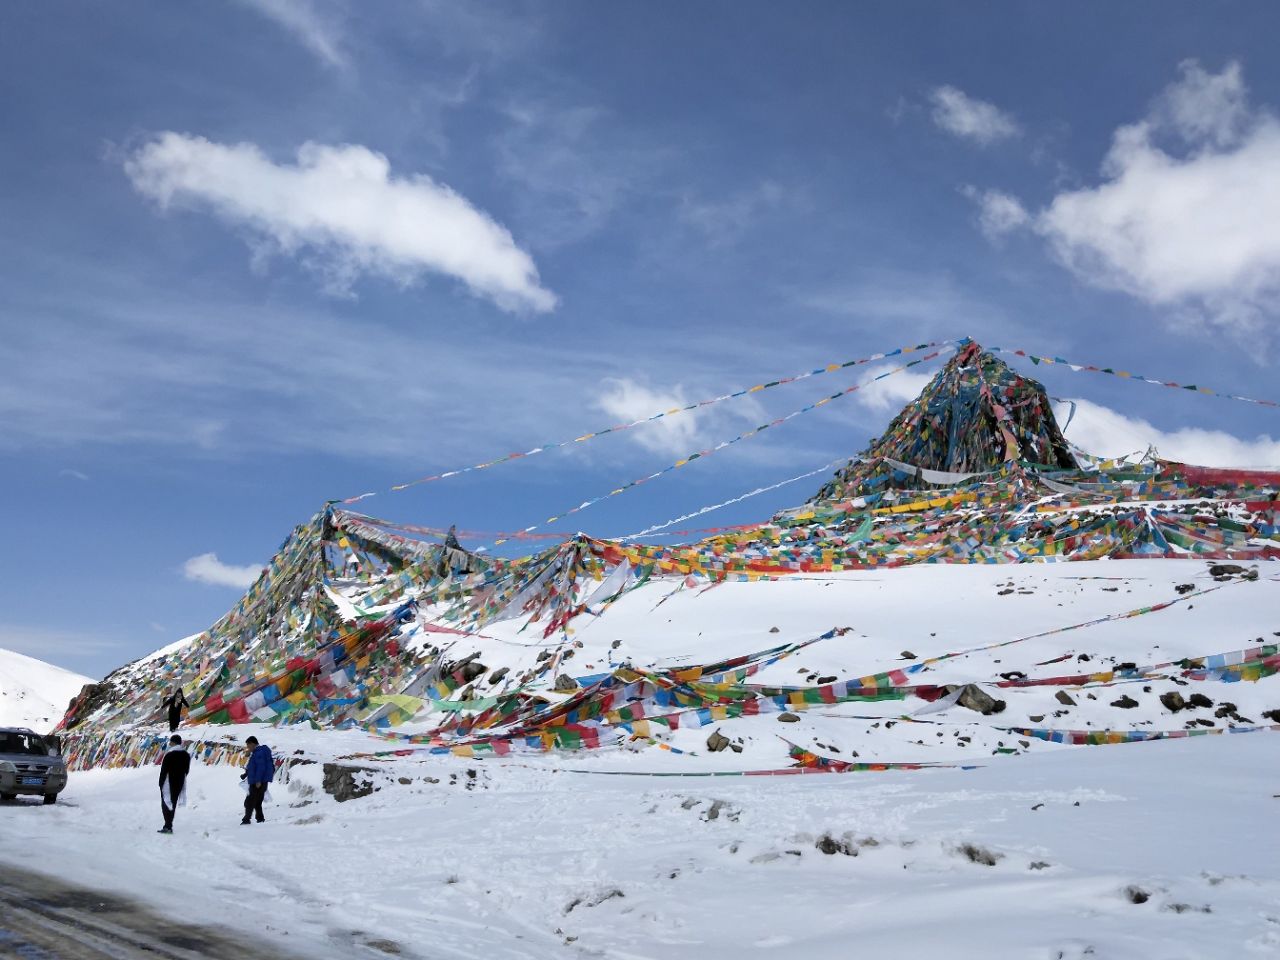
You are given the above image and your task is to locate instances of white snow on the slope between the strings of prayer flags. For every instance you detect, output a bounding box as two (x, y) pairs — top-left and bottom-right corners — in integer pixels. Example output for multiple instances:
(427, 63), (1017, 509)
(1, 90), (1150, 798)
(389, 559), (1280, 769)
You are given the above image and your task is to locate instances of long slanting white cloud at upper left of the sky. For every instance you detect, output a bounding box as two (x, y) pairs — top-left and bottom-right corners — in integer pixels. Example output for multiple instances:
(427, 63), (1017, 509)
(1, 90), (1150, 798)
(124, 132), (556, 311)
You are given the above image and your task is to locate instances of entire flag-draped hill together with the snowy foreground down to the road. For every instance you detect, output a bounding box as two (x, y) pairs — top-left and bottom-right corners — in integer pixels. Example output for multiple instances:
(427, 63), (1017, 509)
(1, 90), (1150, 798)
(10, 348), (1280, 960)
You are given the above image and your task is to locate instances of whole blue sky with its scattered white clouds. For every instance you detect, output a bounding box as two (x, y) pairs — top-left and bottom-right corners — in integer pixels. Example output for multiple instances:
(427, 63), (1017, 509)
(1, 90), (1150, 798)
(0, 0), (1280, 675)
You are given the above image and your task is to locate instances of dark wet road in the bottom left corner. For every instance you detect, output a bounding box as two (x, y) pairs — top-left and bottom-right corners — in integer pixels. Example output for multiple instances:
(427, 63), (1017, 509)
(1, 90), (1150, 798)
(0, 867), (302, 960)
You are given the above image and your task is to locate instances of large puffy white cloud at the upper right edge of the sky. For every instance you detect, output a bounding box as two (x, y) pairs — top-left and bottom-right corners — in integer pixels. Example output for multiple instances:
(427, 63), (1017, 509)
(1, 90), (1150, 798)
(983, 60), (1280, 332)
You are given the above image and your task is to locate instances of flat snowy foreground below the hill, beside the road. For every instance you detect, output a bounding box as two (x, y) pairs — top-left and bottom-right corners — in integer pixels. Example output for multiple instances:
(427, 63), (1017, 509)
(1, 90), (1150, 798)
(0, 733), (1280, 960)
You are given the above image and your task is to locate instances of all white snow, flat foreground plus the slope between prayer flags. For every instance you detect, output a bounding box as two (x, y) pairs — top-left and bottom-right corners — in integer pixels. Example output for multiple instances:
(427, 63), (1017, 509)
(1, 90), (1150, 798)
(0, 561), (1280, 960)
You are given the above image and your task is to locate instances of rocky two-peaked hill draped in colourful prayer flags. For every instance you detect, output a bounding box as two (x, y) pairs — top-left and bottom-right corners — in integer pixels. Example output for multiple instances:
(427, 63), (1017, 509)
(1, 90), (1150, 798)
(64, 342), (1280, 742)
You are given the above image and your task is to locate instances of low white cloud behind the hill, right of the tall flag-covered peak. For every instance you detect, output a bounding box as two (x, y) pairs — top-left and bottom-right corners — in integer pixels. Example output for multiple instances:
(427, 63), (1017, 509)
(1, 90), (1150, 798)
(1059, 399), (1280, 467)
